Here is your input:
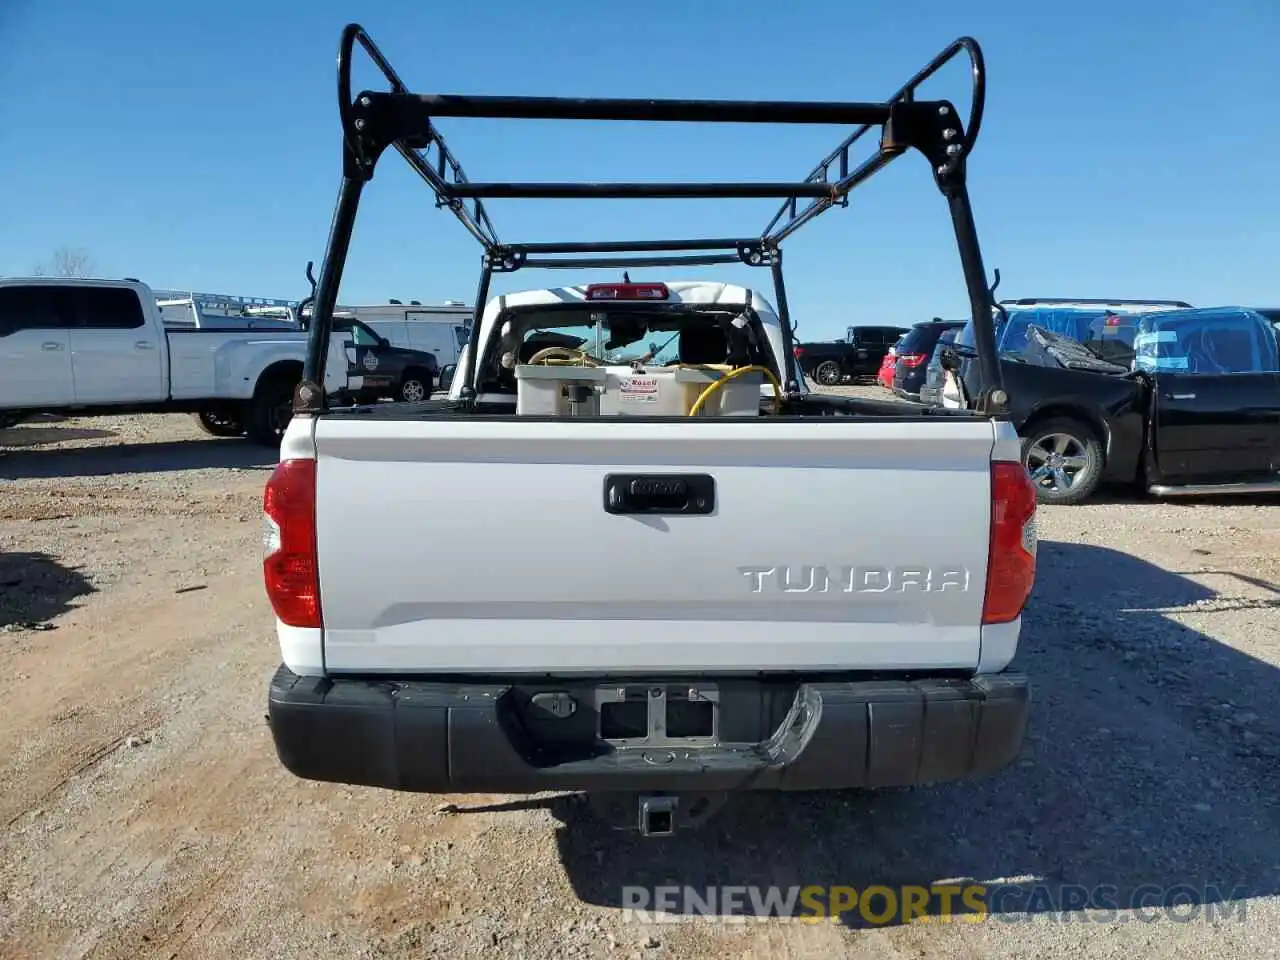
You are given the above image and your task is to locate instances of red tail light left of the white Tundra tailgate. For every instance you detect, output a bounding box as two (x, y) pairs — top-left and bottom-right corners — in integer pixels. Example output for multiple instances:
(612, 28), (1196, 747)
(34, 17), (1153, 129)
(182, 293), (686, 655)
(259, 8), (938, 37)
(262, 460), (321, 627)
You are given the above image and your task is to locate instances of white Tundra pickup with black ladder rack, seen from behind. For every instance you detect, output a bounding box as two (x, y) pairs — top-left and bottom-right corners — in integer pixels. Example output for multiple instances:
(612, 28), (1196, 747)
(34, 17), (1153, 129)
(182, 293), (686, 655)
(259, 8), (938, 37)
(264, 24), (1036, 836)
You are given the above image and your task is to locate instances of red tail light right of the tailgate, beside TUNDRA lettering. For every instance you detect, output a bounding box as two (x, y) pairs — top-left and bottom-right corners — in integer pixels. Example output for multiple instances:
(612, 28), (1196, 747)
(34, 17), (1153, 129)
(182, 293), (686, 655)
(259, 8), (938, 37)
(982, 461), (1036, 623)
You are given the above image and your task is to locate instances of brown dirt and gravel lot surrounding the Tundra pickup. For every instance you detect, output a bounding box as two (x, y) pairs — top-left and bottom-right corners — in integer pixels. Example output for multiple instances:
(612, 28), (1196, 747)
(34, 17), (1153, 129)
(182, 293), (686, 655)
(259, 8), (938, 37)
(0, 391), (1280, 960)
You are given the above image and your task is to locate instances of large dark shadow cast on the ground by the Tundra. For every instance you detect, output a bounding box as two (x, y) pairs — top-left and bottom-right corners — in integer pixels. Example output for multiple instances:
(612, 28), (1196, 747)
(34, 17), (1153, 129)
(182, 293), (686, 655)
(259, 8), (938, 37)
(442, 543), (1280, 927)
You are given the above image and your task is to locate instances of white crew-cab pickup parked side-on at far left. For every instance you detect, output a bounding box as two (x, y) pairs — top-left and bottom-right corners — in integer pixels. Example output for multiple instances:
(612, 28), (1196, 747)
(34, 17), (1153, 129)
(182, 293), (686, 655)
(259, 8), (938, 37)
(0, 278), (349, 445)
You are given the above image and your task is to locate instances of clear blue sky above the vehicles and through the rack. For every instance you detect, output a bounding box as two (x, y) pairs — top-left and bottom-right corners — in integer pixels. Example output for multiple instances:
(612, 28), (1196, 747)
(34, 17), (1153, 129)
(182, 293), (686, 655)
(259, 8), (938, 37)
(0, 0), (1280, 339)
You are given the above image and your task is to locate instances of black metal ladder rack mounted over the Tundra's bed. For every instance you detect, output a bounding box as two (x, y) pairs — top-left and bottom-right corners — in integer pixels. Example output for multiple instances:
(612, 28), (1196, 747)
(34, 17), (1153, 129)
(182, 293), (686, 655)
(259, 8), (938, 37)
(302, 23), (1006, 415)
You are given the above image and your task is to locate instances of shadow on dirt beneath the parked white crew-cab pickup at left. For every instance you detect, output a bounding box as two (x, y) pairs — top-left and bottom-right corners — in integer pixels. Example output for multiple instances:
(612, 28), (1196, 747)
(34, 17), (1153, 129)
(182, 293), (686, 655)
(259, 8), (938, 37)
(0, 437), (280, 480)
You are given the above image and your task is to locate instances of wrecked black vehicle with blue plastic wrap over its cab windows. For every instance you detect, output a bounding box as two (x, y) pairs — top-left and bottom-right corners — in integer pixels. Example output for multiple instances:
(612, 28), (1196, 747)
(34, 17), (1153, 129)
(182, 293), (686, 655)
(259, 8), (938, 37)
(950, 307), (1280, 503)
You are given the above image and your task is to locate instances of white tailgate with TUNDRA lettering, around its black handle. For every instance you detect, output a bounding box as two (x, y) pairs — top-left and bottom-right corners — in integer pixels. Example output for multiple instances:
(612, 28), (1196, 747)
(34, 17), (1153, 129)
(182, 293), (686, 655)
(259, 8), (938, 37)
(315, 416), (995, 675)
